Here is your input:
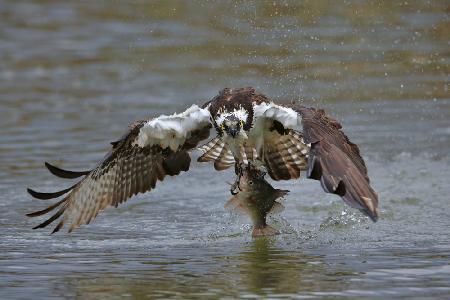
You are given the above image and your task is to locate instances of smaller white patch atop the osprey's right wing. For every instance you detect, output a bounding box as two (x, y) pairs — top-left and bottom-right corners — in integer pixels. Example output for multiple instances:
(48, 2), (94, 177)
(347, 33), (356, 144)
(254, 102), (302, 129)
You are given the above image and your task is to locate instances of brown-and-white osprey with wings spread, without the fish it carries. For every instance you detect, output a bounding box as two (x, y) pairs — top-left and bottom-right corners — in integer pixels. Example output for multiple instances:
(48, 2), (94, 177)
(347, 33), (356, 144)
(27, 88), (378, 232)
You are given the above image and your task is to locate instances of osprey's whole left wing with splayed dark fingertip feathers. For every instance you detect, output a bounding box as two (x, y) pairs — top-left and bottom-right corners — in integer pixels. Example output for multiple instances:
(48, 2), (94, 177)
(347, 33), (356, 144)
(27, 105), (211, 232)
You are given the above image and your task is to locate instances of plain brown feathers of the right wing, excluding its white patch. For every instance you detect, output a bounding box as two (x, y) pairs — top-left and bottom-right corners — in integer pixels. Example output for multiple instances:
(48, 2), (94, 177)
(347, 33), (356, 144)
(291, 104), (378, 221)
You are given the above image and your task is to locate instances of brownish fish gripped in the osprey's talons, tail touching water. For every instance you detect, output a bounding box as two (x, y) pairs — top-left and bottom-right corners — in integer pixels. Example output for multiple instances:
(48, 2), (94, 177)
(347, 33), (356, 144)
(225, 164), (289, 237)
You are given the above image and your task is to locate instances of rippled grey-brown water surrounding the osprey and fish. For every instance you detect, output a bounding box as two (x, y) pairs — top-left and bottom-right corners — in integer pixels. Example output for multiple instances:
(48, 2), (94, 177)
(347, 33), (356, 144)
(0, 0), (450, 299)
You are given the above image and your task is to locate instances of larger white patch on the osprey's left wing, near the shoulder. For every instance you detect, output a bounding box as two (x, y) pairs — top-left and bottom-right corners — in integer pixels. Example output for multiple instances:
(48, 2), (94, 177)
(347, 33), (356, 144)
(134, 105), (211, 151)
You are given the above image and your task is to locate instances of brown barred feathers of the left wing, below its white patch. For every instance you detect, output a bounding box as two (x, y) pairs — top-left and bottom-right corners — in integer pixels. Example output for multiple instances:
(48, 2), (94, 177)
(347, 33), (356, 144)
(28, 121), (211, 232)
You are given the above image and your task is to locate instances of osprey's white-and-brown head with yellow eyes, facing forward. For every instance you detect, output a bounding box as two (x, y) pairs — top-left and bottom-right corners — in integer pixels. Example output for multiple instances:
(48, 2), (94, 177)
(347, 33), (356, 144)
(216, 111), (247, 138)
